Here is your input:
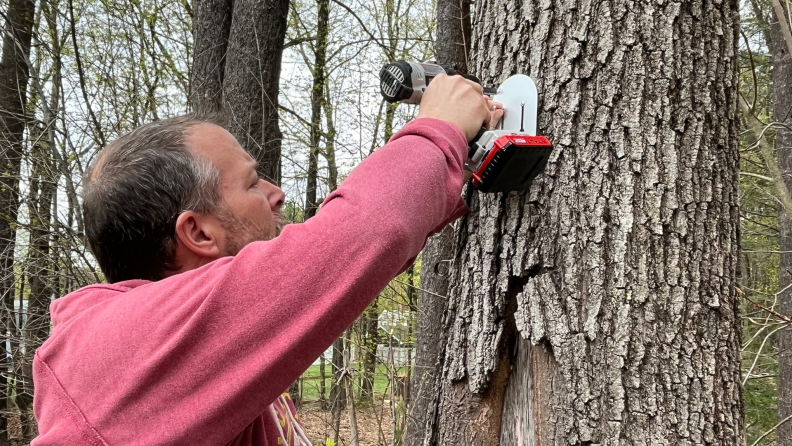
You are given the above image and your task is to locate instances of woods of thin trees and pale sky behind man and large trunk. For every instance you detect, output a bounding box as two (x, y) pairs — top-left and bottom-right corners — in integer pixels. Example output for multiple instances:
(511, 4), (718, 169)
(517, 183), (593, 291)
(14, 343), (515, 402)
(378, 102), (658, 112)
(0, 0), (792, 445)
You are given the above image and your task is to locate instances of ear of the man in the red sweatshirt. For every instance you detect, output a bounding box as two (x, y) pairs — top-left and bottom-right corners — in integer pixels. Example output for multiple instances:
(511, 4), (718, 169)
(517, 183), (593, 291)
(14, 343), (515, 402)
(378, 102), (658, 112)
(176, 211), (223, 263)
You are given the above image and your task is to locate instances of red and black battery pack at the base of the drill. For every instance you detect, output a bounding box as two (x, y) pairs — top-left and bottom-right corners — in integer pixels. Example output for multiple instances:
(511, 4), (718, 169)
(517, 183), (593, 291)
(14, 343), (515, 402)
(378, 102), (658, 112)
(473, 135), (553, 192)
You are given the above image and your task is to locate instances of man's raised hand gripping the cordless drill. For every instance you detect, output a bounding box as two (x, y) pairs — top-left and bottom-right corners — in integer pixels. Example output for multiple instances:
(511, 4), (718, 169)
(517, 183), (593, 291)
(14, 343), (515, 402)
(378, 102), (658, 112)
(418, 74), (492, 142)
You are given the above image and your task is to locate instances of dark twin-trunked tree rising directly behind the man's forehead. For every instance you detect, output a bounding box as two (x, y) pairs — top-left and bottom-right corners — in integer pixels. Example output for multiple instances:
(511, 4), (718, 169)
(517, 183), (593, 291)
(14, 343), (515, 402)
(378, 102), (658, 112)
(190, 0), (289, 184)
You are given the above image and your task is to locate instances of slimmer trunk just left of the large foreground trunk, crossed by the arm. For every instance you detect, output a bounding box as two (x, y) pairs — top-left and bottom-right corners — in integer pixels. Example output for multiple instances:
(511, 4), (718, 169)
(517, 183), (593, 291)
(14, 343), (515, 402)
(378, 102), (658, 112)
(404, 0), (471, 446)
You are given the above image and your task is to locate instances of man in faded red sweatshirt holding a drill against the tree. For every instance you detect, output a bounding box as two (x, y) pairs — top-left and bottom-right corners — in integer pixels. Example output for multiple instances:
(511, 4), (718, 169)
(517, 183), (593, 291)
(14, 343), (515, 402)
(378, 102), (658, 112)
(32, 76), (502, 446)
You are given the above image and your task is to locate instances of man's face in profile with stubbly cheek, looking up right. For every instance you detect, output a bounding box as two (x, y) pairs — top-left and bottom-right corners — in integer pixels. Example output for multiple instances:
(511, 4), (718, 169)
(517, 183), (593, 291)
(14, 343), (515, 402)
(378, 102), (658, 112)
(186, 124), (286, 255)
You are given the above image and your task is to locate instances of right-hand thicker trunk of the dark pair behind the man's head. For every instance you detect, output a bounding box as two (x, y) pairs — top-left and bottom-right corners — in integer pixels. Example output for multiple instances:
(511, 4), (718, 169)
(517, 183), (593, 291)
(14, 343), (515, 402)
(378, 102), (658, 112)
(222, 0), (289, 184)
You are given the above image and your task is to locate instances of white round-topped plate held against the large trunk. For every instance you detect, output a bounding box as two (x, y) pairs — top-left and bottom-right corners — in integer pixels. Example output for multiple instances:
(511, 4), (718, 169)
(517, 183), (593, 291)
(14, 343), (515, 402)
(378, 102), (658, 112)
(492, 74), (539, 136)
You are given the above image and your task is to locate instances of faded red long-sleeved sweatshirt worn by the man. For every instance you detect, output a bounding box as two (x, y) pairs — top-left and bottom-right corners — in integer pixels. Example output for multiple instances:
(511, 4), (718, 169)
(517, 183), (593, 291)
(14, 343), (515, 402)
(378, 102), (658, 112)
(32, 119), (467, 446)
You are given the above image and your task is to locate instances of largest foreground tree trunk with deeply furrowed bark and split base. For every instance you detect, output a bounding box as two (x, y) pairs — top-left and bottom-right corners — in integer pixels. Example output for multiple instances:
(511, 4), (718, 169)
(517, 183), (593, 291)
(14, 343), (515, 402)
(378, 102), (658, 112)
(426, 0), (743, 445)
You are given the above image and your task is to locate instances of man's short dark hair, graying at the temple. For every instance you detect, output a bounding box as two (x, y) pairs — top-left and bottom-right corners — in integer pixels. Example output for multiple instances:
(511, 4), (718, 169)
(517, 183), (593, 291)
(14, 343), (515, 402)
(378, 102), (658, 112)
(83, 113), (223, 283)
